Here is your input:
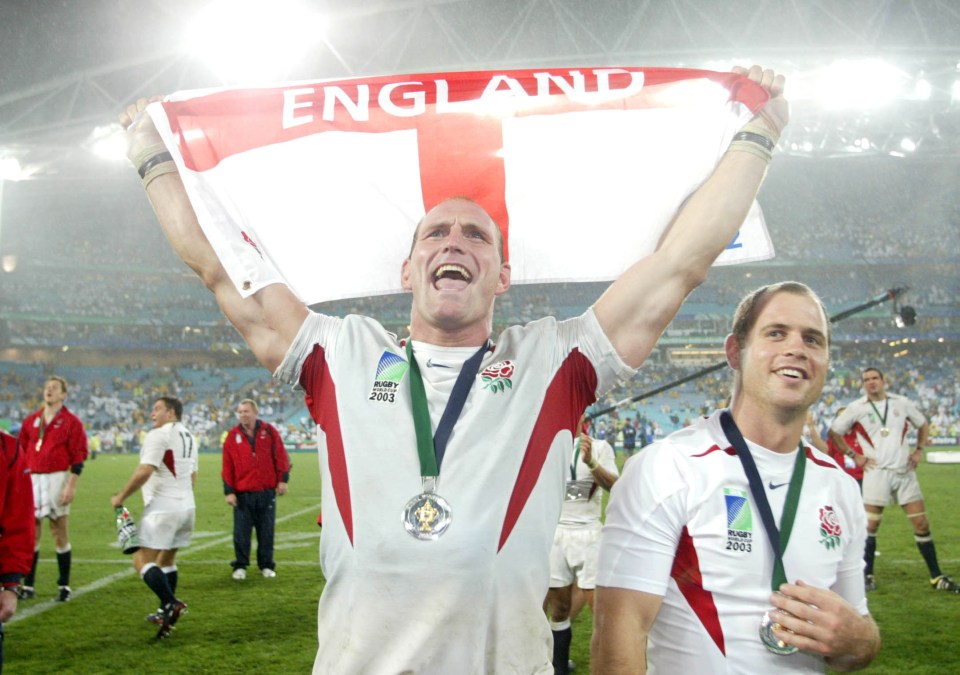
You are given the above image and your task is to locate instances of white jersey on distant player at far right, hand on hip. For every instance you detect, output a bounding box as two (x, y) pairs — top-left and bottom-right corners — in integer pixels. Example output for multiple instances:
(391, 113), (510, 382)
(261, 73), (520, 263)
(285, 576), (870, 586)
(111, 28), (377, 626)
(830, 394), (927, 472)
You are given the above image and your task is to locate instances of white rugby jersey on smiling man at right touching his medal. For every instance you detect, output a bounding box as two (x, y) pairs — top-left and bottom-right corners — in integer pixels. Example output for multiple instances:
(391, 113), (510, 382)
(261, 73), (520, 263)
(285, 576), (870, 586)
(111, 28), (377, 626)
(597, 413), (867, 674)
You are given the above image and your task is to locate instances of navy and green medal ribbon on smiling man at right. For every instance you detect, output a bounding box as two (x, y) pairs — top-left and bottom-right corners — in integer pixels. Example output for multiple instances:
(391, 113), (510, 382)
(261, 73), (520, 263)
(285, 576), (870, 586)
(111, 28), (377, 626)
(720, 410), (807, 591)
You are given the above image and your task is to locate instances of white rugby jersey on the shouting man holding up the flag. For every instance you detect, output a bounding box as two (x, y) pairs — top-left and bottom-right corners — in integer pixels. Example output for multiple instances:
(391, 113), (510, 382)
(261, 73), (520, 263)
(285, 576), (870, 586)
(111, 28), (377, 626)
(276, 310), (633, 674)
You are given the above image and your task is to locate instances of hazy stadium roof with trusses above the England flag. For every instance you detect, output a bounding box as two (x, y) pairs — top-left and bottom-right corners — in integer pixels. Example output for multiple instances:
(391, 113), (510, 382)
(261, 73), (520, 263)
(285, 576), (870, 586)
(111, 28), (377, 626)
(0, 0), (960, 175)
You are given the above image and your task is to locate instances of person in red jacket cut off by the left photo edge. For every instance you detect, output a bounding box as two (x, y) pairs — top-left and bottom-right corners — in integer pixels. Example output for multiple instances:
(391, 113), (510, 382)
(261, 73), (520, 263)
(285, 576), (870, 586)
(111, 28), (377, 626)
(0, 431), (36, 670)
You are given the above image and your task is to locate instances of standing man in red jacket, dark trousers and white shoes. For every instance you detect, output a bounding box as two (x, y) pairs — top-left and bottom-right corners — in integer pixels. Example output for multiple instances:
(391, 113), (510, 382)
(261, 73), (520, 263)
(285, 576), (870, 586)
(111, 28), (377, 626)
(221, 399), (290, 581)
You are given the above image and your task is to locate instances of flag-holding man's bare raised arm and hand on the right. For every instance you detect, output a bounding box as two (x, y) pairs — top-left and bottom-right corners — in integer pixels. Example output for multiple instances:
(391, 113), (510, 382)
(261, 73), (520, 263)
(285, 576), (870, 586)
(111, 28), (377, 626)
(594, 66), (789, 368)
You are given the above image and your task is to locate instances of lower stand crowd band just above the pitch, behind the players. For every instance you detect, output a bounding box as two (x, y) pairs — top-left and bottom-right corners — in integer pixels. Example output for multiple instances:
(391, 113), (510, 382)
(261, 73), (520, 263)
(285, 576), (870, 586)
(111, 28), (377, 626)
(0, 345), (960, 452)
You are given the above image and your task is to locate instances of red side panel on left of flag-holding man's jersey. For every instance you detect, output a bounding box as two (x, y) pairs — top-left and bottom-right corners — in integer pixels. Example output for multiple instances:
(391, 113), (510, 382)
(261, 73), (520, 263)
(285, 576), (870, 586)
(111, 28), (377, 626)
(300, 345), (353, 546)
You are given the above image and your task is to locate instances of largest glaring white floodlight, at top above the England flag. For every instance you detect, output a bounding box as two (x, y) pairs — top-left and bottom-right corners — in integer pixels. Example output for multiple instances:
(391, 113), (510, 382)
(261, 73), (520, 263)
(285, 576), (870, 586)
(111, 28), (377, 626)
(184, 0), (323, 84)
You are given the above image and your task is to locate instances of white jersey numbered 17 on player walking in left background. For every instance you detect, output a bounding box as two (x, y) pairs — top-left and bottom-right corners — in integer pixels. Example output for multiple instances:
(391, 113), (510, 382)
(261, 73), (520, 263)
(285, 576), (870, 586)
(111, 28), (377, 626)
(140, 422), (200, 512)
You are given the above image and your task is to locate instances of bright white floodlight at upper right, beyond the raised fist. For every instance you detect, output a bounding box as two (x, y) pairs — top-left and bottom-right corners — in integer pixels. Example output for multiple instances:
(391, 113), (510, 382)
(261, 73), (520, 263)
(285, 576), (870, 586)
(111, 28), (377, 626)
(815, 58), (908, 110)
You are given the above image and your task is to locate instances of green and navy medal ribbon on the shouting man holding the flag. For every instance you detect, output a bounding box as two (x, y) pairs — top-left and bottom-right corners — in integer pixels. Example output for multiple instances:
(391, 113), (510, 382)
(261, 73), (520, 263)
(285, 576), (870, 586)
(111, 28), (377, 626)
(407, 340), (490, 478)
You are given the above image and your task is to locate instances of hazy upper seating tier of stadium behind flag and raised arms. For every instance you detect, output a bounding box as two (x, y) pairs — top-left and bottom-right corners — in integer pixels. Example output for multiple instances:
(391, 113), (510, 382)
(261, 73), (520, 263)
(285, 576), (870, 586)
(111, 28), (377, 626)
(0, 156), (960, 352)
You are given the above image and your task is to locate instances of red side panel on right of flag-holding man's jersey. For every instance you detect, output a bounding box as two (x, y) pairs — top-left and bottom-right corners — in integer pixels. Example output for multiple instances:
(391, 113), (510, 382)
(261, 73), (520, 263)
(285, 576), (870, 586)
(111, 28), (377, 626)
(497, 349), (597, 553)
